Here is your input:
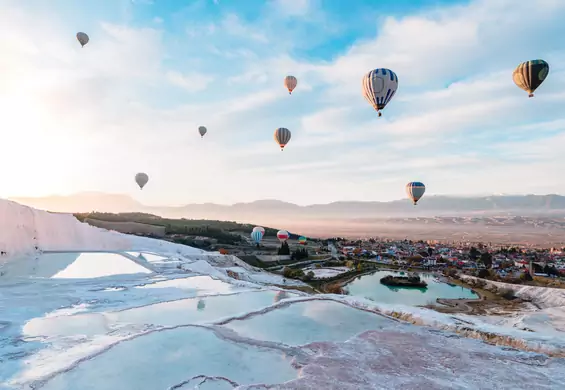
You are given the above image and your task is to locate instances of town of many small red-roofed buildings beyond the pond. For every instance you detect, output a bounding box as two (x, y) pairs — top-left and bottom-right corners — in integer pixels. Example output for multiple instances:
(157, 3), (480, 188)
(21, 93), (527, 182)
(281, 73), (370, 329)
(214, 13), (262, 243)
(328, 238), (565, 276)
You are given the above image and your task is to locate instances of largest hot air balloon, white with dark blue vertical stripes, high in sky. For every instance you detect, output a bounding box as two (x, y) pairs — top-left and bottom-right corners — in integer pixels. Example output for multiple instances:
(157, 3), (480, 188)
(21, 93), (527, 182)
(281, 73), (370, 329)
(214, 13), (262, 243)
(362, 68), (398, 116)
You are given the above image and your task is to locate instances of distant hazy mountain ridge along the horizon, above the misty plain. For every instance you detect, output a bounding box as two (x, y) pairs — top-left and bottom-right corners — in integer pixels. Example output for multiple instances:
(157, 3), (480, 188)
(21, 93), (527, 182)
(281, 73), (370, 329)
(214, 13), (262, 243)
(11, 192), (565, 221)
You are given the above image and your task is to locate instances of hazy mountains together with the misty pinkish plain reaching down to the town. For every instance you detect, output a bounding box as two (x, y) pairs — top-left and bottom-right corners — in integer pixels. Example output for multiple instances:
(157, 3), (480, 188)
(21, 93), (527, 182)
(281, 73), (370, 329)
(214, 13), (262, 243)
(10, 192), (565, 246)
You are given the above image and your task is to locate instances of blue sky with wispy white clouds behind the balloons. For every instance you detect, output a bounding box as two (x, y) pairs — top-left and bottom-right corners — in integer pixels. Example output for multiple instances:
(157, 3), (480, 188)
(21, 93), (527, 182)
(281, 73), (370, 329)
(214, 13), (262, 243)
(0, 0), (565, 205)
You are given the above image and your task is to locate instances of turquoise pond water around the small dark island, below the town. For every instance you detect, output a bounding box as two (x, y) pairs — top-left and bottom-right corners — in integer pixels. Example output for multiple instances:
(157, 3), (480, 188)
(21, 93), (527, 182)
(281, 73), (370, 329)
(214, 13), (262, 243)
(345, 271), (478, 306)
